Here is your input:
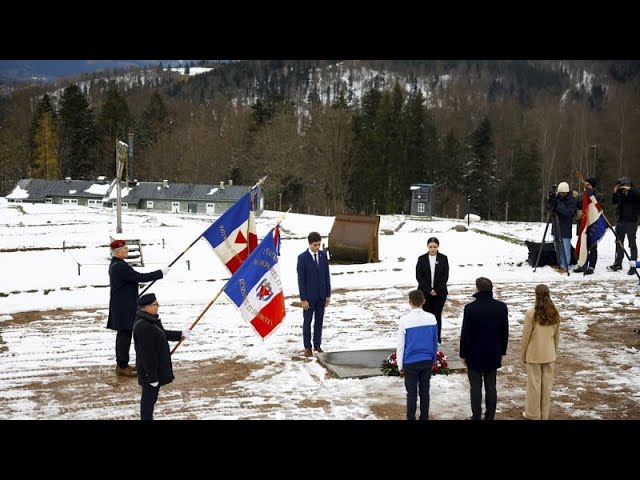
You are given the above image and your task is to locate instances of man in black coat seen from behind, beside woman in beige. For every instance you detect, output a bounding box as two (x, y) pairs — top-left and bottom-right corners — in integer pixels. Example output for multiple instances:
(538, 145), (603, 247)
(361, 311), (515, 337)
(460, 277), (509, 420)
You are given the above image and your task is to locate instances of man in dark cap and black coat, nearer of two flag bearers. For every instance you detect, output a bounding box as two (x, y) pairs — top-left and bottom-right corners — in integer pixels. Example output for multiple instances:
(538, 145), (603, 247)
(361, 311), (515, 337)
(133, 293), (191, 420)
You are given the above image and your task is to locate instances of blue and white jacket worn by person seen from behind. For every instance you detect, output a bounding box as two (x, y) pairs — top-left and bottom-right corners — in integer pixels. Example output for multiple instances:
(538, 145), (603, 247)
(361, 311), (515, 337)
(396, 307), (438, 370)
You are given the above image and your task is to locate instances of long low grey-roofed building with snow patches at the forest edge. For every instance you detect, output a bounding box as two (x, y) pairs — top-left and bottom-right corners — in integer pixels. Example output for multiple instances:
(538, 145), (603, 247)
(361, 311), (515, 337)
(6, 177), (264, 215)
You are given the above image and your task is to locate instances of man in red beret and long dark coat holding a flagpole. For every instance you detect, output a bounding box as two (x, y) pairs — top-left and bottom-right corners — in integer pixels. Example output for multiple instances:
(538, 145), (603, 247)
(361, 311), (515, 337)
(107, 240), (169, 377)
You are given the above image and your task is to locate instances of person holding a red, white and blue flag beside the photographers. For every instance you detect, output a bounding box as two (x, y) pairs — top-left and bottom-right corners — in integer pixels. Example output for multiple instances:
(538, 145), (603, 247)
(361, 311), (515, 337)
(574, 177), (608, 275)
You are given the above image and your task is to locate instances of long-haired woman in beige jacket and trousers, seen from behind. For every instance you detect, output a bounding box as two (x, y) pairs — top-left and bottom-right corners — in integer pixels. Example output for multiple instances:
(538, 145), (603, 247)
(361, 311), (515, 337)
(521, 284), (560, 420)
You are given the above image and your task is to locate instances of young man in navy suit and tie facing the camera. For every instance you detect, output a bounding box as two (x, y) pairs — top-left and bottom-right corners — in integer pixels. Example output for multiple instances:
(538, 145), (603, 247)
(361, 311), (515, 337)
(297, 232), (331, 357)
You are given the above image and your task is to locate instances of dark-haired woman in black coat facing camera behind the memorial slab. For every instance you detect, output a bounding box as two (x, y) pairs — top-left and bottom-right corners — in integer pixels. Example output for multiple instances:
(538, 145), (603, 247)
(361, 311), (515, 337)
(416, 237), (449, 343)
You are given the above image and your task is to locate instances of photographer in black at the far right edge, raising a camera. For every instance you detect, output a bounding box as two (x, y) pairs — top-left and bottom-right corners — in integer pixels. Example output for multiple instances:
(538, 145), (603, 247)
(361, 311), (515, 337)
(607, 177), (640, 275)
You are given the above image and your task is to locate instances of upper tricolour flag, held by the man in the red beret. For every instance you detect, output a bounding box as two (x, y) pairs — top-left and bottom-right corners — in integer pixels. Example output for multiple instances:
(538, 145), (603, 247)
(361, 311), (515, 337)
(202, 188), (258, 273)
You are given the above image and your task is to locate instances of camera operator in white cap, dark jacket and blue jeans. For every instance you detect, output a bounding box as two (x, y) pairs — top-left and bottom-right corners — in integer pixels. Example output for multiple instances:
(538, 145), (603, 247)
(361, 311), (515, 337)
(549, 182), (577, 273)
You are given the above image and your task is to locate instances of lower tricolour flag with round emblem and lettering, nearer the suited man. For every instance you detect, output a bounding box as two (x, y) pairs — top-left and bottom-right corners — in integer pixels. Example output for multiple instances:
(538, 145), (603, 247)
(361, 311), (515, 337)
(224, 227), (285, 338)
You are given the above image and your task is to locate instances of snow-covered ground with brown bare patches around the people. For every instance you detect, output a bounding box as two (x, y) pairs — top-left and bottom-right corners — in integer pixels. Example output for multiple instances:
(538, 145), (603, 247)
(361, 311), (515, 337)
(0, 199), (640, 419)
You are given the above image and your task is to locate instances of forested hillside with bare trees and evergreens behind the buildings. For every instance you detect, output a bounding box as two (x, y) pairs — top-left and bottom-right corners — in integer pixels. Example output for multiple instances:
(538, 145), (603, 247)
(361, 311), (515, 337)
(0, 60), (640, 220)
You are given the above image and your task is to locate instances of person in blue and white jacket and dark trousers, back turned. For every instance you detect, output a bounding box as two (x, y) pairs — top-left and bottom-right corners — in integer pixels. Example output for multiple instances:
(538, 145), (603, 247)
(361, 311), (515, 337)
(396, 290), (438, 420)
